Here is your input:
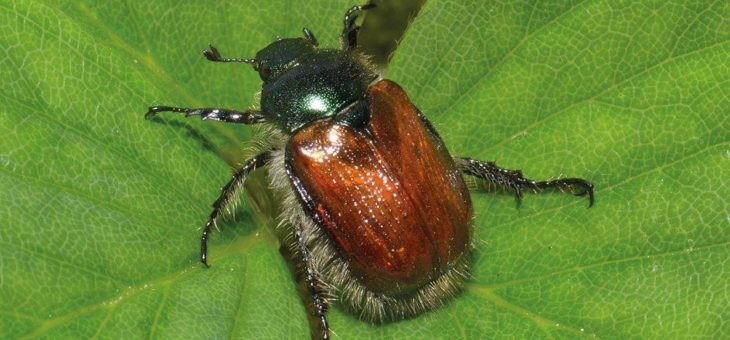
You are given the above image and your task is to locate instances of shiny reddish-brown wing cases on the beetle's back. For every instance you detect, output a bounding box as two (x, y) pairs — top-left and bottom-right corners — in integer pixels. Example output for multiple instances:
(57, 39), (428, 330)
(287, 80), (472, 296)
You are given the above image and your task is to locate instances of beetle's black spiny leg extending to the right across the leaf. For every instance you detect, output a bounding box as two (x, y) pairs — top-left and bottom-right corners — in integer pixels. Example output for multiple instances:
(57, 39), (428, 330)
(454, 157), (594, 207)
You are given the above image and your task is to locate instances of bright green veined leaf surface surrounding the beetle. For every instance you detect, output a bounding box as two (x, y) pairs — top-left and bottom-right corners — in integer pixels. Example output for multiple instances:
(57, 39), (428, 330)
(0, 0), (730, 339)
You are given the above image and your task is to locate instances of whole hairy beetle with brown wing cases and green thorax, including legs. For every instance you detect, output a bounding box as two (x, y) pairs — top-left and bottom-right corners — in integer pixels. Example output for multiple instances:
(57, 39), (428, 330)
(146, 4), (594, 339)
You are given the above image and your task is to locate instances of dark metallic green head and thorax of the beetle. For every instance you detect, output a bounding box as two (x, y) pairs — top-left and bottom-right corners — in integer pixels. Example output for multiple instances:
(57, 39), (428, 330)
(256, 39), (376, 134)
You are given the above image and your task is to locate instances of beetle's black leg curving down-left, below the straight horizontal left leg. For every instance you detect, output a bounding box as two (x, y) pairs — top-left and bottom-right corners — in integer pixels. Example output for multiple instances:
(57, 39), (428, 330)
(200, 151), (271, 267)
